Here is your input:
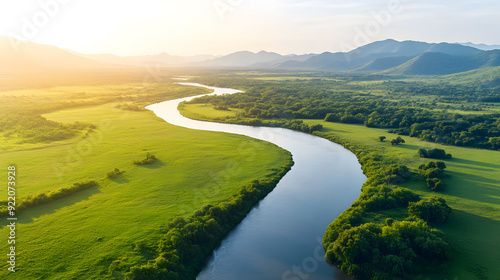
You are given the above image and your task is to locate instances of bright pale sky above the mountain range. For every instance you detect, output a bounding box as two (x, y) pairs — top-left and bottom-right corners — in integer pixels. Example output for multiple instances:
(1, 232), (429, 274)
(0, 0), (500, 55)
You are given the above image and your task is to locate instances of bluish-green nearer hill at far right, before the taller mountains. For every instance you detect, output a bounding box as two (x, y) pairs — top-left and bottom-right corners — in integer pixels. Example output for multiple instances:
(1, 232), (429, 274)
(384, 50), (500, 75)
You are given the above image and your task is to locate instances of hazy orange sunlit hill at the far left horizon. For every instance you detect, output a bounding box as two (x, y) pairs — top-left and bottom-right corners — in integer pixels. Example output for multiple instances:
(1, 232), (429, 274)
(0, 36), (154, 91)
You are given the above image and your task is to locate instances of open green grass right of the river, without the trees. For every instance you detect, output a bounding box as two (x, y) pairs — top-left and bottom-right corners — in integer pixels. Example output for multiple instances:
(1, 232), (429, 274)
(181, 104), (500, 280)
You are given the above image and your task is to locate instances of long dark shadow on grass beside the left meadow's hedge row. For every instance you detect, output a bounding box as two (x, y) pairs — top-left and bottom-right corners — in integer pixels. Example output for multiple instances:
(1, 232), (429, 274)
(2, 185), (101, 228)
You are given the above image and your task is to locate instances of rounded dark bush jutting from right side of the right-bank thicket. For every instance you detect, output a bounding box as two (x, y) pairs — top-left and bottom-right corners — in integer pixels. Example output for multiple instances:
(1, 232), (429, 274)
(408, 196), (452, 224)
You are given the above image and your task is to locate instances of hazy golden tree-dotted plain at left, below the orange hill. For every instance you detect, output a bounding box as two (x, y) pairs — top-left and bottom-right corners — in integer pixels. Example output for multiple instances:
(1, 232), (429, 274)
(0, 82), (209, 150)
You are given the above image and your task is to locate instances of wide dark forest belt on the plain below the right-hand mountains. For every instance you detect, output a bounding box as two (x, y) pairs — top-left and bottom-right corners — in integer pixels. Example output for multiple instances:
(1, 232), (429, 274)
(191, 74), (500, 150)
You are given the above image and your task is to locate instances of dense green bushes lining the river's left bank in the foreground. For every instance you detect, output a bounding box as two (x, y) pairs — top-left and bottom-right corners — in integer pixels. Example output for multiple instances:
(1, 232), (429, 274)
(109, 155), (293, 280)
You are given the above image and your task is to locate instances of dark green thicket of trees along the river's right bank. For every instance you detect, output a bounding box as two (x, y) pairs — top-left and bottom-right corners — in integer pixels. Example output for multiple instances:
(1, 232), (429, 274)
(314, 132), (451, 280)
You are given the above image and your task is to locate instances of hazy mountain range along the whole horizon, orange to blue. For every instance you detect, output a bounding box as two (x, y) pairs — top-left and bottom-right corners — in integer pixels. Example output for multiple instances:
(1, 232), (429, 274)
(0, 36), (500, 77)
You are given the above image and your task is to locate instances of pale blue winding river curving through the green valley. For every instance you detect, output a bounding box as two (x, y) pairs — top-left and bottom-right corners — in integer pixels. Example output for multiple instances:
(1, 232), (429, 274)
(147, 83), (366, 280)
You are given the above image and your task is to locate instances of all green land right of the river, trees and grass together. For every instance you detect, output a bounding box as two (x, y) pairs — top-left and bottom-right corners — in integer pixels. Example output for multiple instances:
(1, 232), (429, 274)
(181, 73), (500, 279)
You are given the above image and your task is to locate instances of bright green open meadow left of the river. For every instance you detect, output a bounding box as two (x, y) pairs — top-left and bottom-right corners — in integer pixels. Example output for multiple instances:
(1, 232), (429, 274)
(0, 85), (290, 280)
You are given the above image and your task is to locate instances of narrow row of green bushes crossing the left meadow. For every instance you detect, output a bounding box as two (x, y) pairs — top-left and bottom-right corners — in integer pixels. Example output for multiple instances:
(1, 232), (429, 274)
(0, 181), (97, 217)
